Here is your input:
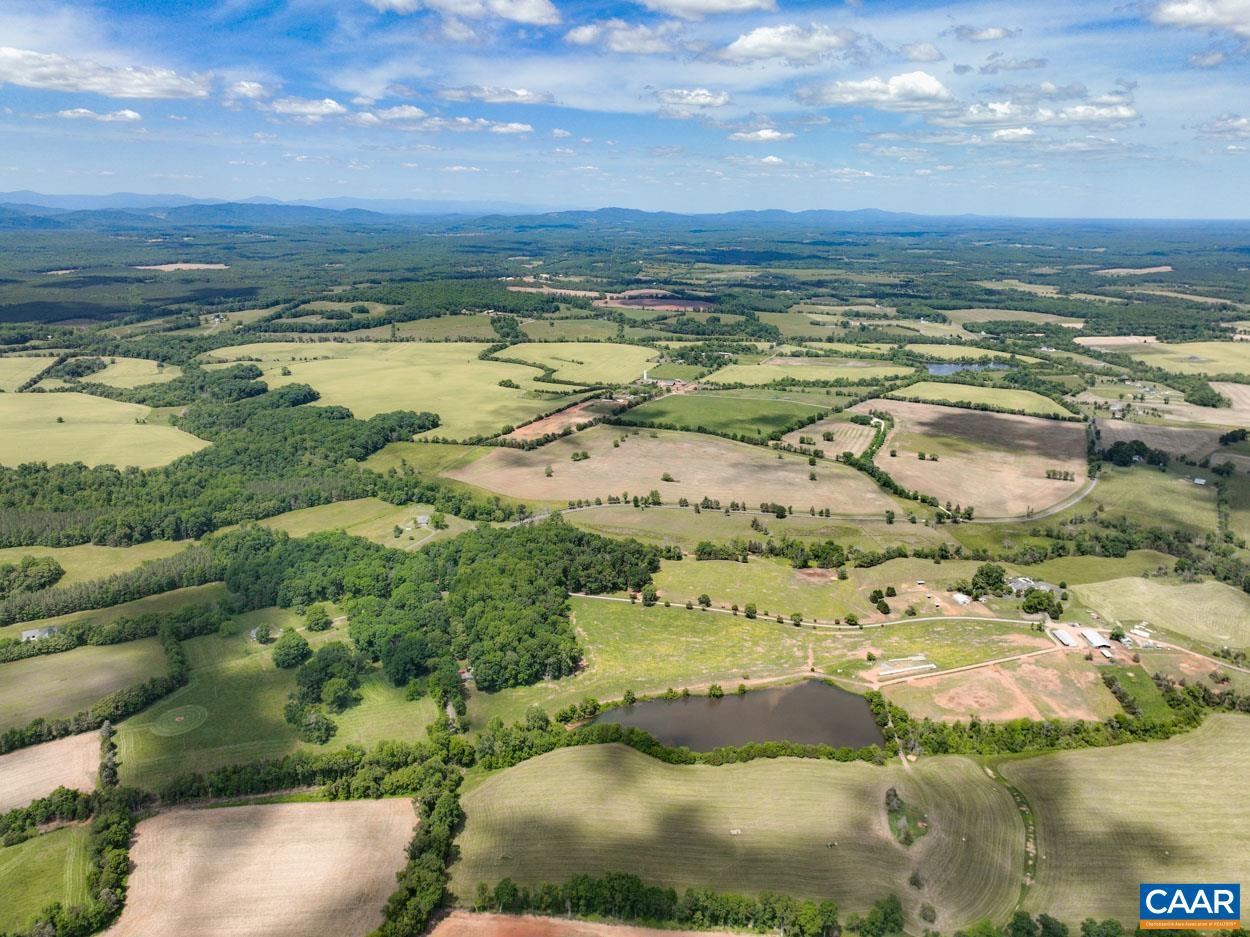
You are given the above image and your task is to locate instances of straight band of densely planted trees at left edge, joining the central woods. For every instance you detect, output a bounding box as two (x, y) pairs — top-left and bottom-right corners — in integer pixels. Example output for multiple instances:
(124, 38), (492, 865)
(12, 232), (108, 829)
(0, 546), (220, 625)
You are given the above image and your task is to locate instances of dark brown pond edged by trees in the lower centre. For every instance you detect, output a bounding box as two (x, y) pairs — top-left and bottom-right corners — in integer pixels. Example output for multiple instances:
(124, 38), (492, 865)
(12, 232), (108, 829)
(595, 680), (884, 752)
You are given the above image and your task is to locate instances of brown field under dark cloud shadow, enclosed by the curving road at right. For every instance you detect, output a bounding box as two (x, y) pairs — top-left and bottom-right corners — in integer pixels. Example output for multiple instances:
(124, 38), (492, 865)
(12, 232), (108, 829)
(855, 397), (1085, 517)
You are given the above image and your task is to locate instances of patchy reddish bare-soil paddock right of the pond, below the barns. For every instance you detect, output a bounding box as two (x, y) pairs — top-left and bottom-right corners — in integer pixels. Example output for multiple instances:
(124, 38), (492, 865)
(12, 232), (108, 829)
(885, 654), (1121, 722)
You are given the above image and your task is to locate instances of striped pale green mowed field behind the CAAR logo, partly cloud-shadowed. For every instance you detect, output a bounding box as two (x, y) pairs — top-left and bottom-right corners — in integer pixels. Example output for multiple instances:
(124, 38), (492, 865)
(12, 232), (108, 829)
(999, 713), (1250, 926)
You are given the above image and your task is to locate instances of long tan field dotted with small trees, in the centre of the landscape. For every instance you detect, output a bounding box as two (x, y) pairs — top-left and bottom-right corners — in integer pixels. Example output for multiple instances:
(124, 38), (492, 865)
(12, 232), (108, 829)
(448, 426), (894, 515)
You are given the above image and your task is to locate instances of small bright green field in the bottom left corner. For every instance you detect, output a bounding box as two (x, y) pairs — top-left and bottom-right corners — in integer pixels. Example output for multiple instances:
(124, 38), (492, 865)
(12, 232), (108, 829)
(0, 823), (90, 933)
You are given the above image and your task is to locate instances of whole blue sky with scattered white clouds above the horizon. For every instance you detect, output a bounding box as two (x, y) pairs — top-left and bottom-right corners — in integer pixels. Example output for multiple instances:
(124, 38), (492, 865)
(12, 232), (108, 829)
(0, 0), (1250, 217)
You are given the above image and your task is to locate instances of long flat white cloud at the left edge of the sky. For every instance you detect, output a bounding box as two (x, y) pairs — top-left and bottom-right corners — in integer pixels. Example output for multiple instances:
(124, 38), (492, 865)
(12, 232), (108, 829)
(0, 46), (210, 97)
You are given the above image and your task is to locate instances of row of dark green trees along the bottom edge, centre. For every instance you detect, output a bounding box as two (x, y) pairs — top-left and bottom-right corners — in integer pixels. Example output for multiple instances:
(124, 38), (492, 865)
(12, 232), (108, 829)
(476, 872), (840, 937)
